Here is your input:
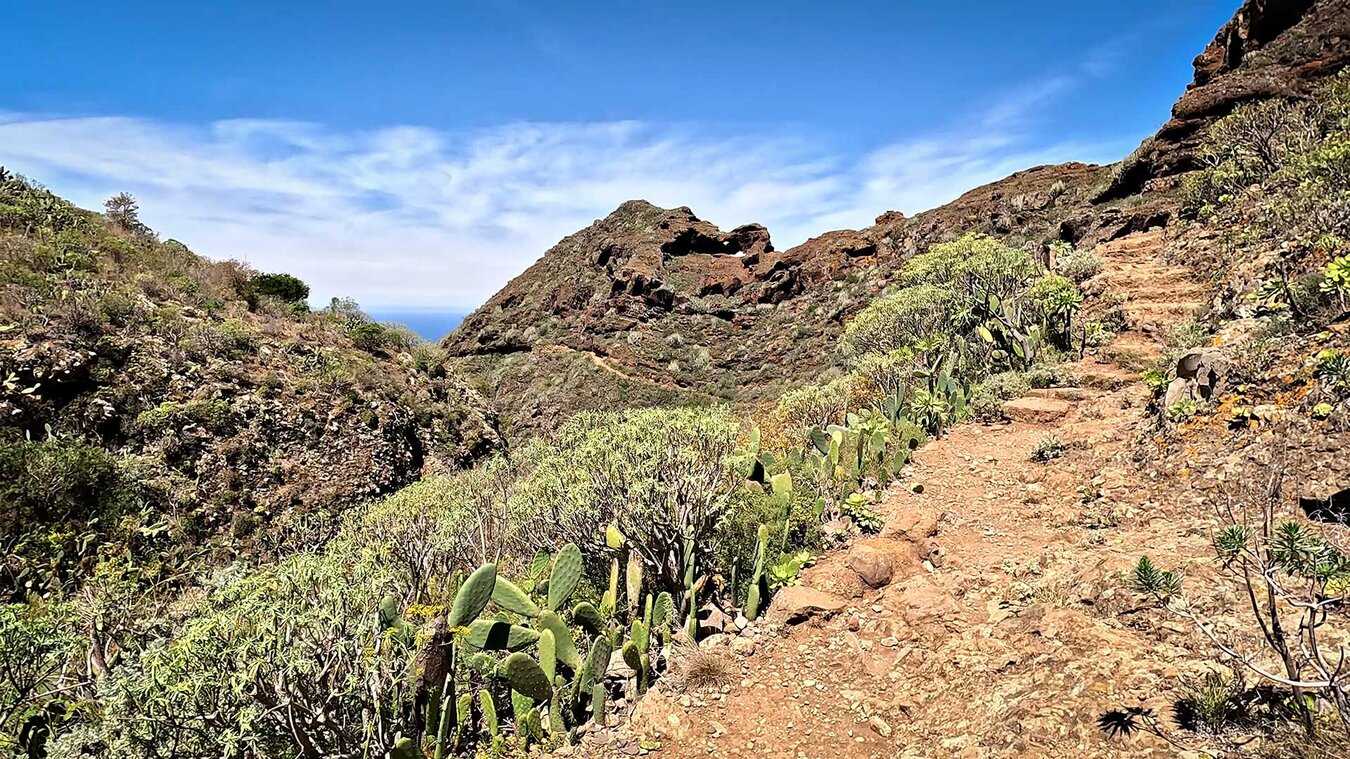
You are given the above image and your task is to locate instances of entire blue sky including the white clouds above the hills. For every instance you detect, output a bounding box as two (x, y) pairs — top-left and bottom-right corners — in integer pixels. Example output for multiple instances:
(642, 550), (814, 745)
(0, 0), (1238, 309)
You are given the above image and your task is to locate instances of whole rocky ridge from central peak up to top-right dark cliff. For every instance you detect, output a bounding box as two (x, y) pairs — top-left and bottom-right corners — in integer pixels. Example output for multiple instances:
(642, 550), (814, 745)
(443, 0), (1350, 429)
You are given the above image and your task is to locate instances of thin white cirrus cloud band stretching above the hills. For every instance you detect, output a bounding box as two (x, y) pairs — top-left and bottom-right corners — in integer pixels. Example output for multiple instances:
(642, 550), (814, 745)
(0, 80), (1137, 309)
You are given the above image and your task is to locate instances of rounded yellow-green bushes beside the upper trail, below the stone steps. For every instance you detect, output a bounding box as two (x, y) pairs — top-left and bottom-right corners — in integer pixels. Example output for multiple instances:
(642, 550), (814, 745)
(779, 235), (1080, 435)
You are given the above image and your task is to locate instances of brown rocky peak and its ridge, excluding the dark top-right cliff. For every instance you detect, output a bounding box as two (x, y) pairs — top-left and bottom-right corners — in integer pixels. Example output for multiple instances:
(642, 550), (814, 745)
(443, 163), (1166, 429)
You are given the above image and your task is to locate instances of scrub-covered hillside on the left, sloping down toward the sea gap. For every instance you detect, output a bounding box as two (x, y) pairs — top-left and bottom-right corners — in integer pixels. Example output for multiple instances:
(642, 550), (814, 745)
(0, 176), (497, 597)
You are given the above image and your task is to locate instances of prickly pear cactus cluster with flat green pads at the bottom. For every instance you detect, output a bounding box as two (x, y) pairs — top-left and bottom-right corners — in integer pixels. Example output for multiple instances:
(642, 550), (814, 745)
(378, 527), (675, 759)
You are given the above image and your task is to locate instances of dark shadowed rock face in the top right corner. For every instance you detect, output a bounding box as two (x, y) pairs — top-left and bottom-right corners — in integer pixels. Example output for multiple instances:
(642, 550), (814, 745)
(1098, 0), (1350, 201)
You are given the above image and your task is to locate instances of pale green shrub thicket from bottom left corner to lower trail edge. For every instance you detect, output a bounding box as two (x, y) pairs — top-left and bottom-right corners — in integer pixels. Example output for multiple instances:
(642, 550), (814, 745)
(0, 409), (847, 758)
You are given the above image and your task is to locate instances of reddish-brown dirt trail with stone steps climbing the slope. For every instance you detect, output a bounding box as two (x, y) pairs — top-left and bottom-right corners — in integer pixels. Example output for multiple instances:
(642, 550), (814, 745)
(581, 231), (1225, 759)
